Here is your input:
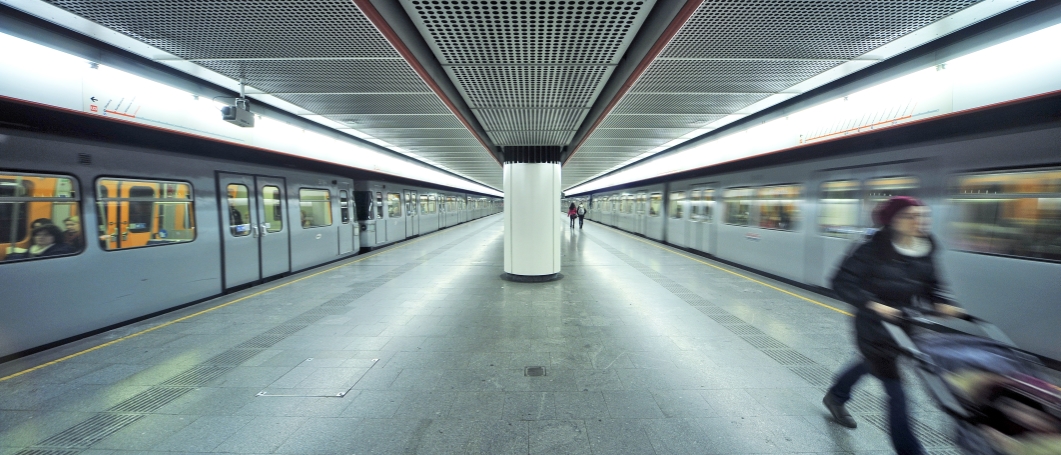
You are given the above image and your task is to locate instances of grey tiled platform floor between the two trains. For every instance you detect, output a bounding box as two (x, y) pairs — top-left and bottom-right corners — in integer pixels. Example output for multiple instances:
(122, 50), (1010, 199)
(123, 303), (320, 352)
(0, 216), (957, 455)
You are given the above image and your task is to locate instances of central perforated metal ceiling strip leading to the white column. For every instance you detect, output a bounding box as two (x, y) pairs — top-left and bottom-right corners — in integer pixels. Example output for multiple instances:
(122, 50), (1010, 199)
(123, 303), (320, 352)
(401, 0), (655, 145)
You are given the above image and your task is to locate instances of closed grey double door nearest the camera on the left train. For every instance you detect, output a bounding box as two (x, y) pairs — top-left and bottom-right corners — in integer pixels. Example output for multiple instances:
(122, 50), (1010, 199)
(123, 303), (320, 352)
(218, 174), (291, 288)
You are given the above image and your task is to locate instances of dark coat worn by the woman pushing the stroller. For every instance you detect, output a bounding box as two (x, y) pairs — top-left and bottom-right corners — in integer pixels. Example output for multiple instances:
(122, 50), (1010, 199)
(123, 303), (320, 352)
(833, 228), (953, 377)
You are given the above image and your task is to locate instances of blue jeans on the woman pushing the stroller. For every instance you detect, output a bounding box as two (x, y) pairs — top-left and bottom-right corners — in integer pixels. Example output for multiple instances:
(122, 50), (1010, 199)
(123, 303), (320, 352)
(829, 361), (924, 455)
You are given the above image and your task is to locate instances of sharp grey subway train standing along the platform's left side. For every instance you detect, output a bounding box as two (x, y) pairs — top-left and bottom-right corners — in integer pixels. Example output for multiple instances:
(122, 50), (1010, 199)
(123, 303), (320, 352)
(0, 129), (501, 362)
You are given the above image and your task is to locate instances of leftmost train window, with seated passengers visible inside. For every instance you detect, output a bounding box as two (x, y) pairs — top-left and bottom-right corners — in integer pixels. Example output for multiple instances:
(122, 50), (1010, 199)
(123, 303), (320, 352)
(0, 171), (85, 261)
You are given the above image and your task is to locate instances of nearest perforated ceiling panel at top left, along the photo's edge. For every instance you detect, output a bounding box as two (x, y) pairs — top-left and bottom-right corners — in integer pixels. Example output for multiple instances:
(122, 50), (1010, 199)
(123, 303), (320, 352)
(46, 0), (399, 59)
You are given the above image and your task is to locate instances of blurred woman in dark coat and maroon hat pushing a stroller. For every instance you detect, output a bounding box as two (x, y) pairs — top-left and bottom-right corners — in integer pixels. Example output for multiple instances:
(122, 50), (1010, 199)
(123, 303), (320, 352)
(823, 196), (962, 455)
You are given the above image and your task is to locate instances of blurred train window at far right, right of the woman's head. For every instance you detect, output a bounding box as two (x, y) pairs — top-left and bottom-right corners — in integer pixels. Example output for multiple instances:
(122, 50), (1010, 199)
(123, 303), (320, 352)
(950, 170), (1061, 261)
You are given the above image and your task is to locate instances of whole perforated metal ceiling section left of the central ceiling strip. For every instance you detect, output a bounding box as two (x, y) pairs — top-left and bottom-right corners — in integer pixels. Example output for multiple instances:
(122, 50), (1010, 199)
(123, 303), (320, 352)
(45, 0), (502, 188)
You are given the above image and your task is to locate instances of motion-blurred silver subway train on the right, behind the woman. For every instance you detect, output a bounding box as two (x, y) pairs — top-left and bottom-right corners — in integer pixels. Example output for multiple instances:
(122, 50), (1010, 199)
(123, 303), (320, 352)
(577, 123), (1061, 360)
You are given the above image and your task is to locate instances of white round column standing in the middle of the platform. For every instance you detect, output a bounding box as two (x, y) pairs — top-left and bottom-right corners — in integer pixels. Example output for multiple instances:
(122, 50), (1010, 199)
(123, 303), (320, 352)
(504, 162), (562, 279)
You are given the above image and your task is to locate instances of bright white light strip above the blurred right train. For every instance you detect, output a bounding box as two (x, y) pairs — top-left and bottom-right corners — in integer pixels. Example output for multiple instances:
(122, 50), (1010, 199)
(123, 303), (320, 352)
(566, 19), (1061, 195)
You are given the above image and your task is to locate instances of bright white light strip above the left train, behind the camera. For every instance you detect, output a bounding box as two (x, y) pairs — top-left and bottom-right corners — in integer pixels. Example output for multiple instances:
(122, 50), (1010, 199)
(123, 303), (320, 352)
(0, 34), (502, 196)
